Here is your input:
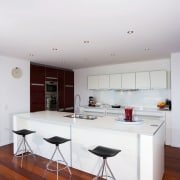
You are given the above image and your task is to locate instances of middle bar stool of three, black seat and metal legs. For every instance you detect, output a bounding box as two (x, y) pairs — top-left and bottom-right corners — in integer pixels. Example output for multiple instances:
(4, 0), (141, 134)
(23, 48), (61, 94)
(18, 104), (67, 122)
(43, 136), (72, 180)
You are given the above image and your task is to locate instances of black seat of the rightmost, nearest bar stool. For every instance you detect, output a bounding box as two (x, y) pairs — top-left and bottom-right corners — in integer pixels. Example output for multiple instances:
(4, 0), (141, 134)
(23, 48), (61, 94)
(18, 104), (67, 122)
(89, 146), (121, 159)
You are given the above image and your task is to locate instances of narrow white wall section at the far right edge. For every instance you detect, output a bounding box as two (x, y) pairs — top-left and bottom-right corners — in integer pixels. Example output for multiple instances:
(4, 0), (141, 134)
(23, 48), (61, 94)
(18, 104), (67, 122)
(171, 53), (180, 147)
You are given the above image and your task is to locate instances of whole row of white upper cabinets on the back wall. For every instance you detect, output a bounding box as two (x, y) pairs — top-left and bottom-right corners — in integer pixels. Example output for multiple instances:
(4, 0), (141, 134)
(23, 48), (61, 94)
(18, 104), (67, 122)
(88, 70), (167, 90)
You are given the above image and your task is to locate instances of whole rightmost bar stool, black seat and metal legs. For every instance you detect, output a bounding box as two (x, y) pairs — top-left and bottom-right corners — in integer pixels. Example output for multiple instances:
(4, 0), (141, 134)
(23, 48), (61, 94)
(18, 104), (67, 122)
(88, 146), (121, 180)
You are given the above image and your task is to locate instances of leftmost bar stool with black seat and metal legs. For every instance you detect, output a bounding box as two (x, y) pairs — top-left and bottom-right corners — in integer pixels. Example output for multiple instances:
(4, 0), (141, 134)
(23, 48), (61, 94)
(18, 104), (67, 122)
(12, 129), (36, 168)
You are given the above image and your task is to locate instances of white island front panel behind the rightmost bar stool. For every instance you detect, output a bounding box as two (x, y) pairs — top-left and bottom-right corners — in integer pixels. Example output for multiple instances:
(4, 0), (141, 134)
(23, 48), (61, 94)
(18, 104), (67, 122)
(72, 126), (139, 180)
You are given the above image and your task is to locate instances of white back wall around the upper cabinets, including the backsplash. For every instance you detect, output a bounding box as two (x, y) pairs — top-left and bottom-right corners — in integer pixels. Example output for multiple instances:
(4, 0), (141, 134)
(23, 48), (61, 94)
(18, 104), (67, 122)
(74, 59), (170, 107)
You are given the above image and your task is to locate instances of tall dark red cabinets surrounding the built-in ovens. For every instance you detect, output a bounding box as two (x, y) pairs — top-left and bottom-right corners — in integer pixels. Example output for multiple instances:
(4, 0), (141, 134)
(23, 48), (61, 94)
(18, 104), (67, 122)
(30, 63), (74, 112)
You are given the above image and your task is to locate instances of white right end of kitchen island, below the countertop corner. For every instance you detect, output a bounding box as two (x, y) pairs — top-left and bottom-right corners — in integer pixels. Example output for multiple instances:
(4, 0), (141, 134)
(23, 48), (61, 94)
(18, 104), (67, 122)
(140, 123), (165, 180)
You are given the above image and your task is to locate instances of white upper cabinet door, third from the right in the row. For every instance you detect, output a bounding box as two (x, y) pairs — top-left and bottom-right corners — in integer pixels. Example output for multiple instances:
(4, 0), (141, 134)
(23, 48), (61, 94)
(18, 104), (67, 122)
(122, 73), (135, 89)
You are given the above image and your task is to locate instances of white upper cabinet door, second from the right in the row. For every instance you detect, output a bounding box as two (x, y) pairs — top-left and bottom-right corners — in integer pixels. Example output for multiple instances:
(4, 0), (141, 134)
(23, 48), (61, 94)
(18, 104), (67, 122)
(136, 72), (150, 89)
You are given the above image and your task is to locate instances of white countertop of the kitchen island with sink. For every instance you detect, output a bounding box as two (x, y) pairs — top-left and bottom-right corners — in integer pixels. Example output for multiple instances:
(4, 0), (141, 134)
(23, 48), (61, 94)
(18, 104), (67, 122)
(14, 111), (165, 136)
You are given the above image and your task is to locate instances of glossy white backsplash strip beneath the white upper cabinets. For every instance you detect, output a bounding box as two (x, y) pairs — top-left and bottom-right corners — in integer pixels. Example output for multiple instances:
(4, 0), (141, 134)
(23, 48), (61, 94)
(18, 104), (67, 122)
(91, 89), (171, 108)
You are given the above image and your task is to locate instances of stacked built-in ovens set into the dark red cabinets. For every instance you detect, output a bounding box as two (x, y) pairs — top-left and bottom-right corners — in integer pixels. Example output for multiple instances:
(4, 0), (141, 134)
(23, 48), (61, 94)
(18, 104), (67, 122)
(45, 81), (58, 111)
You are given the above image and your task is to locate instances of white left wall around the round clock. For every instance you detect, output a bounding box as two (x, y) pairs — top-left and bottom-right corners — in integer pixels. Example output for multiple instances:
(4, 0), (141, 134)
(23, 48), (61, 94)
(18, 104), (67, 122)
(0, 56), (30, 146)
